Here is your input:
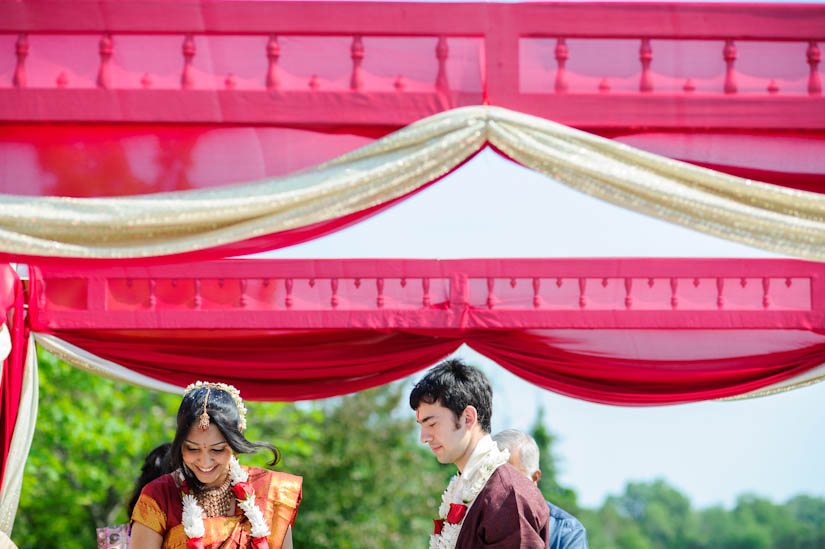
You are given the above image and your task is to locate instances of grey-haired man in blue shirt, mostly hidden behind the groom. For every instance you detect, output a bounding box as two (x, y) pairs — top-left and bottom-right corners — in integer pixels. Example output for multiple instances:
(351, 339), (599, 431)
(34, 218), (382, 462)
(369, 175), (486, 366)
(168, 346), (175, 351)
(493, 429), (587, 549)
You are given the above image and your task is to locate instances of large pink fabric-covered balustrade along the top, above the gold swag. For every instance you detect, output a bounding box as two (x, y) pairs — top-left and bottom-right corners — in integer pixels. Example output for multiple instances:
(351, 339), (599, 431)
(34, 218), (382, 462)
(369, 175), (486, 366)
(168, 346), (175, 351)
(0, 0), (825, 131)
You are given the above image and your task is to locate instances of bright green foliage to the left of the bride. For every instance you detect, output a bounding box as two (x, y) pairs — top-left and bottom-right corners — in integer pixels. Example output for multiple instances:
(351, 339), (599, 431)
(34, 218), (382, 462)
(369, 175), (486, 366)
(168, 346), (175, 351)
(12, 352), (179, 547)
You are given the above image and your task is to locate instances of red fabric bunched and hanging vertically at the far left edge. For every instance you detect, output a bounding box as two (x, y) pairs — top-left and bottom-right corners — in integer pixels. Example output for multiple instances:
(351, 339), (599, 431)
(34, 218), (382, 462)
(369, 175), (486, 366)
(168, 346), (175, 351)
(0, 264), (28, 488)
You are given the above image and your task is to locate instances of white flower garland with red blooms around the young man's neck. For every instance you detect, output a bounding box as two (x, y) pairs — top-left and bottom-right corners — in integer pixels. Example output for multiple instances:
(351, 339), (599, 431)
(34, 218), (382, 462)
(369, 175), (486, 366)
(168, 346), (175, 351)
(430, 435), (510, 549)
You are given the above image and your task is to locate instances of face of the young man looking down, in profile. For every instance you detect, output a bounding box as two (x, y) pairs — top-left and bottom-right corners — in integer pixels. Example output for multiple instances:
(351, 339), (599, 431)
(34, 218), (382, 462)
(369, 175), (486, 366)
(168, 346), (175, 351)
(415, 402), (471, 463)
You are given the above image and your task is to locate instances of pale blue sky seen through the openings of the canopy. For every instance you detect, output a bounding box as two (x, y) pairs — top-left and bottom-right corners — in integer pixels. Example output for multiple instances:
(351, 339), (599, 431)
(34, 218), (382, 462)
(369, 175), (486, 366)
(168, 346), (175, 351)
(264, 151), (825, 507)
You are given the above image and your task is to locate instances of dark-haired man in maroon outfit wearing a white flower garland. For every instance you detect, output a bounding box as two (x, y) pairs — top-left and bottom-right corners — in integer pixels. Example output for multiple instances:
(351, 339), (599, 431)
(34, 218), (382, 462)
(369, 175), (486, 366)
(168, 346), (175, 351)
(410, 360), (549, 549)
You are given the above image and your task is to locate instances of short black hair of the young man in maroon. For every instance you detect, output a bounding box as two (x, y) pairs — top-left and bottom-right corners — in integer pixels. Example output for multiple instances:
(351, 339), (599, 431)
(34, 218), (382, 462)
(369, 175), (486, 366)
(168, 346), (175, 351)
(410, 359), (493, 433)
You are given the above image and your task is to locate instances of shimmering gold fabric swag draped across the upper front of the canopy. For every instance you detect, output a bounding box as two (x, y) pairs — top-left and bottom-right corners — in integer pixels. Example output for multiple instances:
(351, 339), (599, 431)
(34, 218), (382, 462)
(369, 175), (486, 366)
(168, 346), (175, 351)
(0, 106), (825, 261)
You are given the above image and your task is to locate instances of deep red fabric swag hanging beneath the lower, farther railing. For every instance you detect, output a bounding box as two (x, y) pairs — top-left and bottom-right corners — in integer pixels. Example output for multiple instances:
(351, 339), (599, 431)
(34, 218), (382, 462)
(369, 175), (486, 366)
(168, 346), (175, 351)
(32, 330), (825, 406)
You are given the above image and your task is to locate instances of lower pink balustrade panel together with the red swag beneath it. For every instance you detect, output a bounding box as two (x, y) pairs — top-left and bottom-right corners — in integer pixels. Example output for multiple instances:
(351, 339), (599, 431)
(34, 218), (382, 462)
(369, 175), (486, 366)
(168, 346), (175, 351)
(24, 259), (825, 405)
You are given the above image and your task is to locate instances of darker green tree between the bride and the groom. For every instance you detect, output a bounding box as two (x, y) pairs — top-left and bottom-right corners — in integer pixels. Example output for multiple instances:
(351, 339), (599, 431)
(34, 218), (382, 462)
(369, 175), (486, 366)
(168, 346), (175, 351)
(285, 384), (456, 549)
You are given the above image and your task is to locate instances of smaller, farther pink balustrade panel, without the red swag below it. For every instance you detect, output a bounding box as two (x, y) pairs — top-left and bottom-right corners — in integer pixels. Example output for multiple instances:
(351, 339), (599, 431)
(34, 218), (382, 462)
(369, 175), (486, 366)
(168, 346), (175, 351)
(30, 259), (825, 330)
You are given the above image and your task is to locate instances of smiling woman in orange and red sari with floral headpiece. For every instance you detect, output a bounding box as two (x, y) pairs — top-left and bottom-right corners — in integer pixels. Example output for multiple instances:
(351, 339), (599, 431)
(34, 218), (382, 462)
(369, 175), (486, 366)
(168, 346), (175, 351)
(129, 381), (302, 549)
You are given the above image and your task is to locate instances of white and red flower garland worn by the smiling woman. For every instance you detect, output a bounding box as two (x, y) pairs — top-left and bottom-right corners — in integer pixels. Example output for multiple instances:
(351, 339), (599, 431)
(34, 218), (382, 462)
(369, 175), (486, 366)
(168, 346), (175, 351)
(181, 456), (270, 549)
